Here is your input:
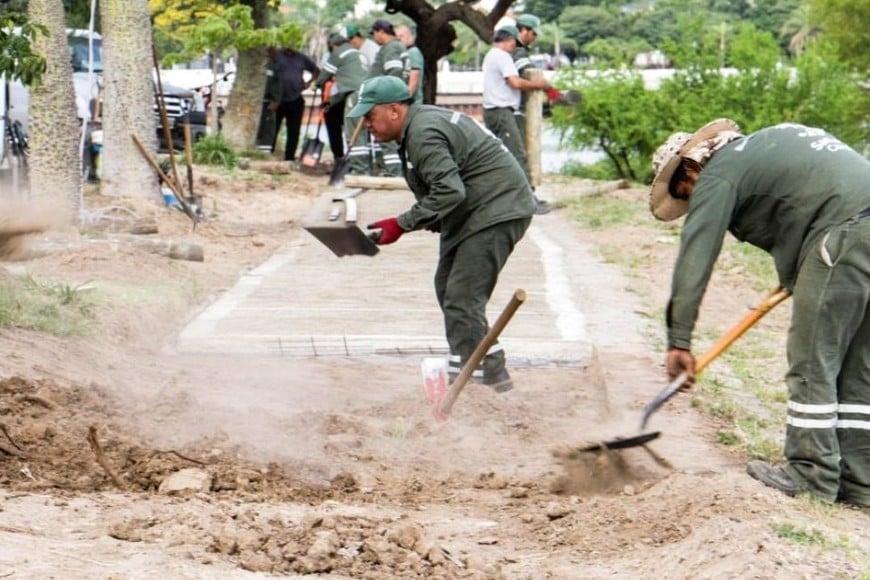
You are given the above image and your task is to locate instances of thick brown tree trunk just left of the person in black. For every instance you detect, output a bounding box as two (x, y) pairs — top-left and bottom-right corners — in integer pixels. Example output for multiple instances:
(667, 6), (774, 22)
(223, 0), (269, 150)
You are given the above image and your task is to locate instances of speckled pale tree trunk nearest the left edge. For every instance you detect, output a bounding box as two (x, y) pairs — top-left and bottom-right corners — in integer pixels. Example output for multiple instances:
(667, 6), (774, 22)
(27, 0), (82, 218)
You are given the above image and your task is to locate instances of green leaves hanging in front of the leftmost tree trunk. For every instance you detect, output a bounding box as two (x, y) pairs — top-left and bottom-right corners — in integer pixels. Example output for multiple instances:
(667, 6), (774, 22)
(0, 17), (48, 87)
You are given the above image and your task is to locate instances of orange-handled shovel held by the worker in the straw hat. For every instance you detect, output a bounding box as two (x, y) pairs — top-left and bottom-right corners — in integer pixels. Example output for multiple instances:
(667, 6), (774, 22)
(580, 286), (791, 451)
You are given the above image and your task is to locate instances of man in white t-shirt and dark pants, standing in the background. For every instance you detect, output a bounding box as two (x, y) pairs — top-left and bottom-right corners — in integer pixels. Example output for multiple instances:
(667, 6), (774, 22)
(483, 24), (550, 214)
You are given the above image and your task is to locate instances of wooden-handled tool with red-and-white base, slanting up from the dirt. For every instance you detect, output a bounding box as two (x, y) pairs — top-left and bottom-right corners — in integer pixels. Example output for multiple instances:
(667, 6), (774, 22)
(422, 289), (526, 422)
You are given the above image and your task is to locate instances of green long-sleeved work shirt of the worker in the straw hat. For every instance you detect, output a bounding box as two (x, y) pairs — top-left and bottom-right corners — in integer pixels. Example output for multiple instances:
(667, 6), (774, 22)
(668, 123), (870, 349)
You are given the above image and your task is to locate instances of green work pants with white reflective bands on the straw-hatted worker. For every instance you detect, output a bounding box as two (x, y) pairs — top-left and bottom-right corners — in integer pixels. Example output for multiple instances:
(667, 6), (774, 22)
(785, 217), (870, 506)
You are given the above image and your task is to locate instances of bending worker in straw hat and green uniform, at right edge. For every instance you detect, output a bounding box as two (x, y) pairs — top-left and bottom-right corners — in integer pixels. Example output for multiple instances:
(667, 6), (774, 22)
(650, 119), (870, 507)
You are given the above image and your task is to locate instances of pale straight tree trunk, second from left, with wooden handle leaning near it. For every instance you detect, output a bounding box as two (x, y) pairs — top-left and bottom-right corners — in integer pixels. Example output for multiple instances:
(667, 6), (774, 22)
(100, 0), (159, 200)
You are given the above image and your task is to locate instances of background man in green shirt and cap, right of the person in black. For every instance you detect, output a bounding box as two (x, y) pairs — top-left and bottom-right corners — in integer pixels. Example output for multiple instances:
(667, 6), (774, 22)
(316, 26), (371, 175)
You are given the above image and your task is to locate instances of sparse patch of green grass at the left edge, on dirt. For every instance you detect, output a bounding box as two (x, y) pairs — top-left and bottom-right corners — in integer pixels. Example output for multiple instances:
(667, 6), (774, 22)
(0, 276), (96, 337)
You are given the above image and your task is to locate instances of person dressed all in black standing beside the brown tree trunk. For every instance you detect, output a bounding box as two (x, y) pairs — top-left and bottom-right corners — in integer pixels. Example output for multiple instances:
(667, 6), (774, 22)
(269, 47), (320, 163)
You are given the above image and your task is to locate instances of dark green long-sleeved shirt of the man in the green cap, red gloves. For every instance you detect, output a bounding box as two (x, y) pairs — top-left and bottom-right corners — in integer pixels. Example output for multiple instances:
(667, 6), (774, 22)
(398, 104), (535, 255)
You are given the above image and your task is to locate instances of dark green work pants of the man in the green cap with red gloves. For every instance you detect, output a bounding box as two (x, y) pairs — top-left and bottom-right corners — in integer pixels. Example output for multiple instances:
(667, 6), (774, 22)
(435, 218), (531, 375)
